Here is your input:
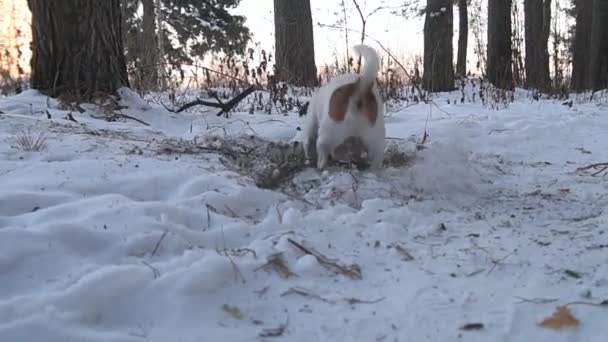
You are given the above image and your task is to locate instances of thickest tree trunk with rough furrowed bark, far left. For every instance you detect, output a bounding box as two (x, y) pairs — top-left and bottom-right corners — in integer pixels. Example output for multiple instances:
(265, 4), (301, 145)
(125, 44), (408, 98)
(28, 0), (129, 101)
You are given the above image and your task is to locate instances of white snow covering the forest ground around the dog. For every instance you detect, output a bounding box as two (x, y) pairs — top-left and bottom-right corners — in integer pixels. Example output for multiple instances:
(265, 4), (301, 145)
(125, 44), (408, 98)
(0, 90), (608, 342)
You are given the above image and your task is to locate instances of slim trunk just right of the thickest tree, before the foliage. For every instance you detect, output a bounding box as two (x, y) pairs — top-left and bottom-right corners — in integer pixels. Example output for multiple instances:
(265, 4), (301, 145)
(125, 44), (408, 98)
(140, 0), (159, 90)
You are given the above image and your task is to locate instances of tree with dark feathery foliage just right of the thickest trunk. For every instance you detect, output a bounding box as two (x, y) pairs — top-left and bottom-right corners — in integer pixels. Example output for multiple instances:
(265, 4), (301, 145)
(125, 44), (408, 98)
(122, 0), (251, 86)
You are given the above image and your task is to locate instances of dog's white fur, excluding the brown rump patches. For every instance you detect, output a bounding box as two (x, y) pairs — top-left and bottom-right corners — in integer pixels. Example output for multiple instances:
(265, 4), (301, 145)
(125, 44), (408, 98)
(304, 45), (386, 170)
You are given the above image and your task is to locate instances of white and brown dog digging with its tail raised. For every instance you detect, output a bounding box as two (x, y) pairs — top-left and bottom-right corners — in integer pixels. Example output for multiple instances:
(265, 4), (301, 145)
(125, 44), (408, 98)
(304, 45), (386, 170)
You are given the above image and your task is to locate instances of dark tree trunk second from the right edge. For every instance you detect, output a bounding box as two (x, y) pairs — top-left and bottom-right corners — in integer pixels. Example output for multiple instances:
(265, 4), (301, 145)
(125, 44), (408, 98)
(572, 0), (593, 91)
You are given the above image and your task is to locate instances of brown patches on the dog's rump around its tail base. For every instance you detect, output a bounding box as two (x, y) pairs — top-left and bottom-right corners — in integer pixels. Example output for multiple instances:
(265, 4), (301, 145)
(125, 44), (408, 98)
(329, 78), (378, 126)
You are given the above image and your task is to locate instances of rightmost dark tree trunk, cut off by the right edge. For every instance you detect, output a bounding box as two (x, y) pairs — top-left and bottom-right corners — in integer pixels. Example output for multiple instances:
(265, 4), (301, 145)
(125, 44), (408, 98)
(587, 0), (608, 90)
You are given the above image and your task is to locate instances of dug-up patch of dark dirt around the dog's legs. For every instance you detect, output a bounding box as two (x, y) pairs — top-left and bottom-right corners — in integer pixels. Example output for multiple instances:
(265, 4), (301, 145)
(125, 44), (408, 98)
(154, 136), (414, 189)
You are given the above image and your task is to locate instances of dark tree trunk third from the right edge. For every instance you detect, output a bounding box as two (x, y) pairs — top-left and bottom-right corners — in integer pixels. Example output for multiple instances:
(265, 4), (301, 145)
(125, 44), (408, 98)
(524, 0), (551, 90)
